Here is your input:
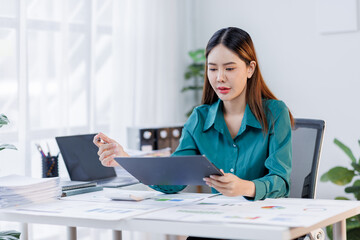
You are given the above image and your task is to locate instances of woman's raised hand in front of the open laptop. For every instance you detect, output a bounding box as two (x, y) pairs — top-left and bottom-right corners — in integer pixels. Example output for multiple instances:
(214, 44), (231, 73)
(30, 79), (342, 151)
(93, 133), (129, 167)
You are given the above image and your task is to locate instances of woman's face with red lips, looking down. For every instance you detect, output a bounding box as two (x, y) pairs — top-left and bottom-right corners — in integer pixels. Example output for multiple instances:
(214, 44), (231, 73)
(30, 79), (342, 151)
(207, 44), (256, 104)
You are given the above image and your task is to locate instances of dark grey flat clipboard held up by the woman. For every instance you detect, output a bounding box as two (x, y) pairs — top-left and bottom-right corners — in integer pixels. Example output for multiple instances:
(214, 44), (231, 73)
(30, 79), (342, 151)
(115, 155), (223, 185)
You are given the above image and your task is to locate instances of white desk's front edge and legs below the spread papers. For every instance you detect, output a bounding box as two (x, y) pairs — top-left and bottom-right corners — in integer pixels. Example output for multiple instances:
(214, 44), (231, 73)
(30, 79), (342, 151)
(0, 189), (360, 240)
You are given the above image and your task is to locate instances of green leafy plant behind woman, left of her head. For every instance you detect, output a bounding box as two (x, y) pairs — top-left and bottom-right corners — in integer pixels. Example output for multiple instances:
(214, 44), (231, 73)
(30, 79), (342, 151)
(181, 49), (206, 116)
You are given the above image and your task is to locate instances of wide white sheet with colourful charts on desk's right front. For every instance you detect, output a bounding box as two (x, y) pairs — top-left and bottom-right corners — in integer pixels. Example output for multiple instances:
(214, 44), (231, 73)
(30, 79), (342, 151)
(137, 197), (360, 227)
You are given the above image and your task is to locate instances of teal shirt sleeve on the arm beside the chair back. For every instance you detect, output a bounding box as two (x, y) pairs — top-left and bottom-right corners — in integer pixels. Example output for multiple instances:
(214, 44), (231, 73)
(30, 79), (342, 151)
(253, 107), (292, 200)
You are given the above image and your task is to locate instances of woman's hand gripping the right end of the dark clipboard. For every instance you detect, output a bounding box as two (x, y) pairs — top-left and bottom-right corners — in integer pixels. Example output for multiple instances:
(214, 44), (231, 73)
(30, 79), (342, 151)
(204, 169), (255, 197)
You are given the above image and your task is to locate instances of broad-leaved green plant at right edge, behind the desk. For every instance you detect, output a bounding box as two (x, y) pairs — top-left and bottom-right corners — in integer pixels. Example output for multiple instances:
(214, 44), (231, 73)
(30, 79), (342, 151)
(320, 138), (360, 240)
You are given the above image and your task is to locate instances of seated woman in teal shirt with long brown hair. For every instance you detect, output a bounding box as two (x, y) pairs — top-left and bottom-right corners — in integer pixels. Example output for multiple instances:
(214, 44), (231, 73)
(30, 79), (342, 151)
(94, 27), (293, 200)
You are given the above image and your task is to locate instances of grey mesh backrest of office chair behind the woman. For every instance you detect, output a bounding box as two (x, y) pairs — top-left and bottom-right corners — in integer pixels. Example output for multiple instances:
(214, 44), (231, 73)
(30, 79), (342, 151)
(289, 118), (325, 198)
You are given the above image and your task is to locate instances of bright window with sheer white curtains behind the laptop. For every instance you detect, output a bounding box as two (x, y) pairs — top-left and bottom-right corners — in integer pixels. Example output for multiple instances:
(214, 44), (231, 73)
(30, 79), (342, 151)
(0, 0), (113, 177)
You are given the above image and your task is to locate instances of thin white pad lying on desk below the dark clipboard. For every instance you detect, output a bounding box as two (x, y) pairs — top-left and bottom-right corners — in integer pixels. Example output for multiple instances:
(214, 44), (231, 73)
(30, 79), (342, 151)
(105, 190), (161, 201)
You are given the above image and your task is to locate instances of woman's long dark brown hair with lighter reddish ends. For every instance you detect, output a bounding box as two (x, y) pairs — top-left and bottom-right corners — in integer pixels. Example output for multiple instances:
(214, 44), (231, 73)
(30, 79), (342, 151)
(201, 27), (294, 132)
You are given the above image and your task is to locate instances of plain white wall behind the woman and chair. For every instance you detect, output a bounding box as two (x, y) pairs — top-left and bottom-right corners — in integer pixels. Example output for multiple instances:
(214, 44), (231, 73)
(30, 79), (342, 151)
(194, 0), (360, 198)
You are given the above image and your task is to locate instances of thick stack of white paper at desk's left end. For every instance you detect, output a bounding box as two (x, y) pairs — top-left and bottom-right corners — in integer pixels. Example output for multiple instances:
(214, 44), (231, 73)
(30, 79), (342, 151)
(0, 175), (61, 208)
